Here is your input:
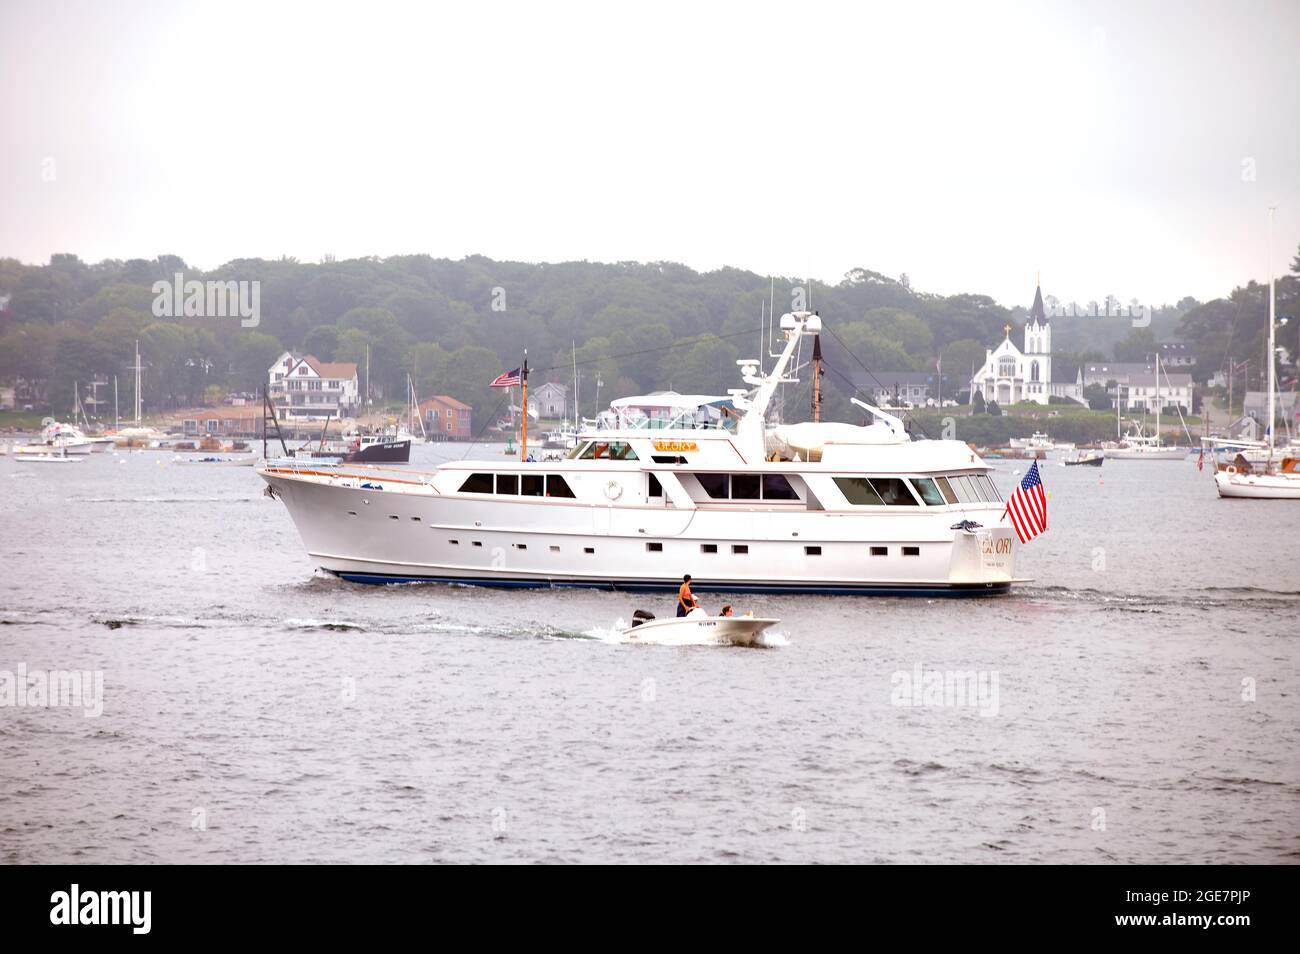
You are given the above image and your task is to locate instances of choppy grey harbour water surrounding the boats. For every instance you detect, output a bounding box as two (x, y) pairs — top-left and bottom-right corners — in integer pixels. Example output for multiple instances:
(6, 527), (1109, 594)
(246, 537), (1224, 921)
(0, 447), (1300, 863)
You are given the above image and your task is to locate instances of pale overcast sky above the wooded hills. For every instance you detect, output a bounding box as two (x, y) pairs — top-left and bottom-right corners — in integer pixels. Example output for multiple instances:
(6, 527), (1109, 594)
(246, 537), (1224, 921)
(0, 0), (1300, 304)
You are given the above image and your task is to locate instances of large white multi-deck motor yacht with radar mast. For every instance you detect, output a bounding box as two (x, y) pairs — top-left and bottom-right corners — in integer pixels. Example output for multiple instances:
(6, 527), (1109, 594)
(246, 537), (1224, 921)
(259, 312), (1019, 595)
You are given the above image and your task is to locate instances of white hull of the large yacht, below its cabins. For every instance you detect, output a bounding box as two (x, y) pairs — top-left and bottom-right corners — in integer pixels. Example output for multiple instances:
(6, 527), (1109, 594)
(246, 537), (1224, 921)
(261, 467), (1018, 595)
